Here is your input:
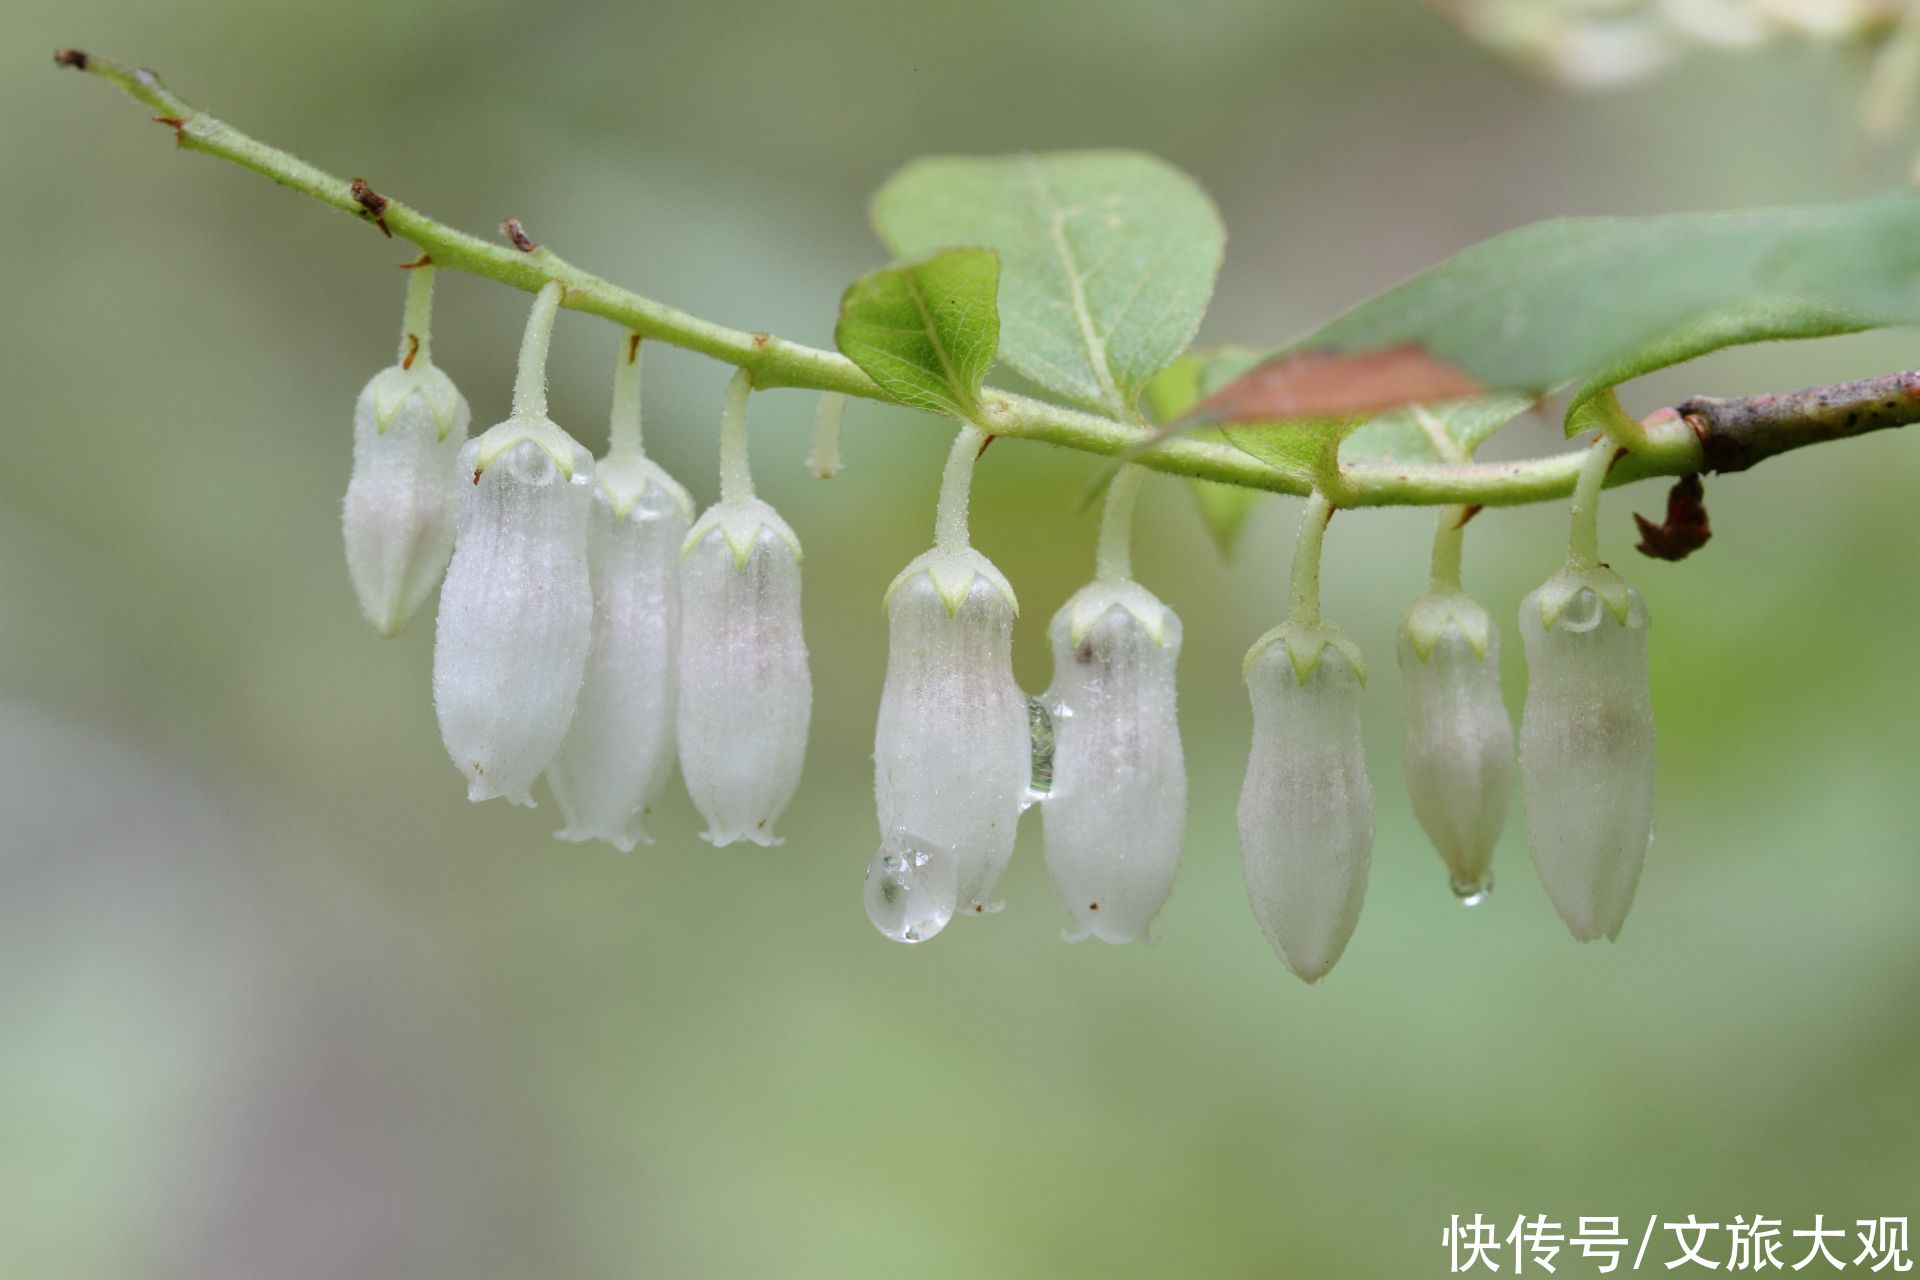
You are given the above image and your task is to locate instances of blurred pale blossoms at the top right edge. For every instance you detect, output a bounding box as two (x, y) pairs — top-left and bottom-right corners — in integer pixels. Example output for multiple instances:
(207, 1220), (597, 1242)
(1442, 0), (1908, 88)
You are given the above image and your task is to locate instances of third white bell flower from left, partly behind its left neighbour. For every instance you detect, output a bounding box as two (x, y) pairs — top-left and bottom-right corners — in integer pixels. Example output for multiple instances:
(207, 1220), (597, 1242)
(547, 334), (693, 852)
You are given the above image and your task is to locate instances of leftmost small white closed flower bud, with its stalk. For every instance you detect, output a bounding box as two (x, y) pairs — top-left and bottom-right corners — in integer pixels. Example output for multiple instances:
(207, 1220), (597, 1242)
(340, 267), (470, 635)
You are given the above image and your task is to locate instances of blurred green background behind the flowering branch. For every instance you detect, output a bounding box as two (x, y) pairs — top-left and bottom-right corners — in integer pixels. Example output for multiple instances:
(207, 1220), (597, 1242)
(0, 0), (1920, 1280)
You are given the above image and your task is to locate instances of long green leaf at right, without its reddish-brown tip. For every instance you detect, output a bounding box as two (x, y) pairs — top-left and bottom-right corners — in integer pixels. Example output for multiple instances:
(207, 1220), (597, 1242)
(1259, 194), (1920, 426)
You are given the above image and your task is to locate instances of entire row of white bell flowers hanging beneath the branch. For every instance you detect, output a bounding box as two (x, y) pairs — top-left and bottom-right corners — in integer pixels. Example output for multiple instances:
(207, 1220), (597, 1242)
(344, 278), (1653, 983)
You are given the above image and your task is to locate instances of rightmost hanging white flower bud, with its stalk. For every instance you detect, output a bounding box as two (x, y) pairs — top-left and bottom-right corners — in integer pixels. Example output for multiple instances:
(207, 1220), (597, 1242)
(1521, 441), (1653, 942)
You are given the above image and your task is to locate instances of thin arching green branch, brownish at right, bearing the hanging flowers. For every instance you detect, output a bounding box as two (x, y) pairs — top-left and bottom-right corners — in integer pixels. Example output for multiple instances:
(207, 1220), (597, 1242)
(54, 50), (1920, 507)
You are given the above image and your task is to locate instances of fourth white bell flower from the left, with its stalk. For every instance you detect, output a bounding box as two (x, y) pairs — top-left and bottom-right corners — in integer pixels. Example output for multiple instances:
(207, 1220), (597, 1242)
(678, 370), (814, 846)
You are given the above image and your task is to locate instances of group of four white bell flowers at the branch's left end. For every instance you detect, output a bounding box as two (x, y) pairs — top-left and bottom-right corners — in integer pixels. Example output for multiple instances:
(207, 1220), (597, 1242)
(344, 278), (812, 850)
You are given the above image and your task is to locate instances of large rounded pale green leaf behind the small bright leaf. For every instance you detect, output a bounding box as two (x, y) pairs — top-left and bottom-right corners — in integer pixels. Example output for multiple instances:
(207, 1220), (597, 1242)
(874, 152), (1225, 418)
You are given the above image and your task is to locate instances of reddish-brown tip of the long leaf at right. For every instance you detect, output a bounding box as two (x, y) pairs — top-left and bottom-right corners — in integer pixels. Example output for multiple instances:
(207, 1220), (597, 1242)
(1187, 342), (1486, 424)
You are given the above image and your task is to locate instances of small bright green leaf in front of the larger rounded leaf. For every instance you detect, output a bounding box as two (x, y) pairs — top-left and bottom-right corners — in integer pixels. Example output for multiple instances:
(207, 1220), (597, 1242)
(833, 249), (1000, 420)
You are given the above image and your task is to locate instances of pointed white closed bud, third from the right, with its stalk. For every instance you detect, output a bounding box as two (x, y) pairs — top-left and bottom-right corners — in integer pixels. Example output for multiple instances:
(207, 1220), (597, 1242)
(1238, 493), (1373, 983)
